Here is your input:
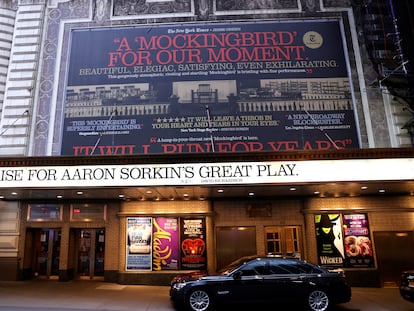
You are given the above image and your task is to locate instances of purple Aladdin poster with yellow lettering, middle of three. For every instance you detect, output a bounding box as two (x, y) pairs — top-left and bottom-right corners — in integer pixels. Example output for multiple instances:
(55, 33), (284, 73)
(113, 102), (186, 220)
(152, 217), (180, 271)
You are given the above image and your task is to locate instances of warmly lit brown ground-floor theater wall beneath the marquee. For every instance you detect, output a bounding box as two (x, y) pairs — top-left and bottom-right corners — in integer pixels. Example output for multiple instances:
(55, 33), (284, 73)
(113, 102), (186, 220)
(4, 184), (414, 286)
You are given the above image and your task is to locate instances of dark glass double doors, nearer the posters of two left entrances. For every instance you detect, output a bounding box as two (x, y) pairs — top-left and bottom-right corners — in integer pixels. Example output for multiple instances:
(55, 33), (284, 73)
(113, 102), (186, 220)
(69, 229), (105, 279)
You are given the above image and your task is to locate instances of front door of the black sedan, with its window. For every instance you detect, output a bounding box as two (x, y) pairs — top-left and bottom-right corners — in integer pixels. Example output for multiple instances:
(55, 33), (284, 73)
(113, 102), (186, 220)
(217, 260), (266, 302)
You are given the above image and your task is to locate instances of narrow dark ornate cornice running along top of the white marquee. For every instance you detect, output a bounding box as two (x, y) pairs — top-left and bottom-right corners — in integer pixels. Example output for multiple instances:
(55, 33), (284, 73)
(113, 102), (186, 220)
(0, 148), (414, 167)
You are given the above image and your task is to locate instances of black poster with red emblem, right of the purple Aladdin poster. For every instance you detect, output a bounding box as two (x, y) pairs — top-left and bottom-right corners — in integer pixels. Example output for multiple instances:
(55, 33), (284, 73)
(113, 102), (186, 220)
(180, 218), (207, 270)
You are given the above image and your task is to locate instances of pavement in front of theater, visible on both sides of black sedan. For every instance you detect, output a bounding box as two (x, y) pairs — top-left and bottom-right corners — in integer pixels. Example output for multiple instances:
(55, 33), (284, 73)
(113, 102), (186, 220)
(0, 280), (414, 311)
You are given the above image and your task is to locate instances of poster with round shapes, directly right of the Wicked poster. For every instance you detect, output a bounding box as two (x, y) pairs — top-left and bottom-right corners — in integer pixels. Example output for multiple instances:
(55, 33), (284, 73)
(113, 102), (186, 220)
(343, 214), (374, 268)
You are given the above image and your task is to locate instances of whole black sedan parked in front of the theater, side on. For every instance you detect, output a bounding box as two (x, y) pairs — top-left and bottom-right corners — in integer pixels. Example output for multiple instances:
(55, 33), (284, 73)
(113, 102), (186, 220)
(170, 256), (351, 311)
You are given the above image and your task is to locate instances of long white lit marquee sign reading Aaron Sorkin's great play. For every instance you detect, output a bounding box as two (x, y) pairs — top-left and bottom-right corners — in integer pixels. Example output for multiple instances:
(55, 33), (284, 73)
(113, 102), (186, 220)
(0, 158), (414, 189)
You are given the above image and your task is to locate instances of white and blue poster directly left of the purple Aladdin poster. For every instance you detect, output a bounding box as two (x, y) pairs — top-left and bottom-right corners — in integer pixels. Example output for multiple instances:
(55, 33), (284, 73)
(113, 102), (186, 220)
(126, 217), (152, 270)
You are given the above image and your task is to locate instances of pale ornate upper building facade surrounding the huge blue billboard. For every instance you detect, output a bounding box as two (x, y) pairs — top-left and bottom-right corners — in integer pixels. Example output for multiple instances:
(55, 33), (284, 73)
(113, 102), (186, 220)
(0, 0), (410, 156)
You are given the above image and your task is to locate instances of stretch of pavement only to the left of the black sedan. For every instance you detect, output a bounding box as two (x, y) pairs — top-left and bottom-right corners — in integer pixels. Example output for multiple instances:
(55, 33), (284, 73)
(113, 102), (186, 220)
(0, 280), (174, 311)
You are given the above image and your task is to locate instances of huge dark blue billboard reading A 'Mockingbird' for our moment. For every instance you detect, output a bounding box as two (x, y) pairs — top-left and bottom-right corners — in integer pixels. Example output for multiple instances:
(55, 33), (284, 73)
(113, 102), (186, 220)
(61, 20), (360, 156)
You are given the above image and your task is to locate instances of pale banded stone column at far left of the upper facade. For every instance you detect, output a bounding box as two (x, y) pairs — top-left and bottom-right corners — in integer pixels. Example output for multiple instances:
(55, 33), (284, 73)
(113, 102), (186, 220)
(0, 1), (45, 156)
